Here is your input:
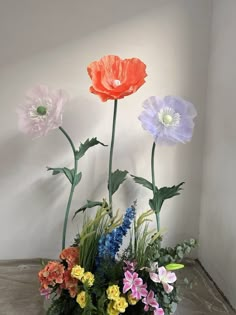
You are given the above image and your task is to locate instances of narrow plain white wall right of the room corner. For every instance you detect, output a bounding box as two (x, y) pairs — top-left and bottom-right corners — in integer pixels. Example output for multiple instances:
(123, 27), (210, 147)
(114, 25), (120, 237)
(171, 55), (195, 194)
(199, 0), (236, 307)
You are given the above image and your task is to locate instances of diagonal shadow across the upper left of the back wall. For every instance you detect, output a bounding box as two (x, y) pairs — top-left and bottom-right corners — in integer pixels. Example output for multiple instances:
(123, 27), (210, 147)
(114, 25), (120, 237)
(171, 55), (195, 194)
(0, 0), (160, 66)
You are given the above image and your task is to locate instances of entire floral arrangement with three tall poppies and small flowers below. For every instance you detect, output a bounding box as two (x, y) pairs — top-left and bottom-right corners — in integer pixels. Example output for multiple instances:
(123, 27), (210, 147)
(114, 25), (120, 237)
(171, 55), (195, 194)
(18, 55), (196, 315)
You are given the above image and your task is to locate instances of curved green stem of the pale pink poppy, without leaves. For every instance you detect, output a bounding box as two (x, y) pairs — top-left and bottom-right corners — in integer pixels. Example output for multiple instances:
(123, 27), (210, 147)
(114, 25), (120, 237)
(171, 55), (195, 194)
(59, 127), (78, 249)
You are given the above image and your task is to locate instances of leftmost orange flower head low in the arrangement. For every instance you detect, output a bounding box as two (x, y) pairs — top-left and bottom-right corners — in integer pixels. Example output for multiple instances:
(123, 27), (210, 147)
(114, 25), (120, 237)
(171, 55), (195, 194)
(38, 261), (65, 289)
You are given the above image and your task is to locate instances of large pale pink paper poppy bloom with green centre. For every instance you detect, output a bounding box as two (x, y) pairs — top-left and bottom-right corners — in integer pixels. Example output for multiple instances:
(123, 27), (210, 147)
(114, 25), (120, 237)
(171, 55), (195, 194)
(17, 85), (68, 137)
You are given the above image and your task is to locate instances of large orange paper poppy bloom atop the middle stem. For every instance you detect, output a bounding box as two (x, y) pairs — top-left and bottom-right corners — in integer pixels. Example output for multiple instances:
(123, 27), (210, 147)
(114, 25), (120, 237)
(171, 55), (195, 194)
(87, 55), (147, 102)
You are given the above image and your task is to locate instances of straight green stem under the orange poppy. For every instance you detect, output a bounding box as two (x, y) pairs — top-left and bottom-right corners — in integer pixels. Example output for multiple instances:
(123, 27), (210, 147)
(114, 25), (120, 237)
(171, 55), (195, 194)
(108, 100), (118, 218)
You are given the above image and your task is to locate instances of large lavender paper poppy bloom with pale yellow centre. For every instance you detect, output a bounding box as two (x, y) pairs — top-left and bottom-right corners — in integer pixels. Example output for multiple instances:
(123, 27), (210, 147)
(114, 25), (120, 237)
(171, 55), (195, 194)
(139, 96), (197, 144)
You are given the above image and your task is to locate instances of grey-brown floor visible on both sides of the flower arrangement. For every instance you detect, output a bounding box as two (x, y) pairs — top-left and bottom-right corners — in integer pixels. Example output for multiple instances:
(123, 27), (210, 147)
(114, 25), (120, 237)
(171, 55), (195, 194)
(0, 260), (236, 315)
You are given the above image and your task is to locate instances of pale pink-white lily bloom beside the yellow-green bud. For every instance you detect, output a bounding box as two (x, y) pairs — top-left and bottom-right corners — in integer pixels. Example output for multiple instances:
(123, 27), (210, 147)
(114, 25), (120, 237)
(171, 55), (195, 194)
(149, 267), (177, 293)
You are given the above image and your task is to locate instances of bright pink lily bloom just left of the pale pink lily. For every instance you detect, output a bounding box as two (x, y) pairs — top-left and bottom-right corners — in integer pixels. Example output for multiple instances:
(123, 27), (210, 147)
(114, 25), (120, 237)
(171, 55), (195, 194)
(123, 270), (148, 300)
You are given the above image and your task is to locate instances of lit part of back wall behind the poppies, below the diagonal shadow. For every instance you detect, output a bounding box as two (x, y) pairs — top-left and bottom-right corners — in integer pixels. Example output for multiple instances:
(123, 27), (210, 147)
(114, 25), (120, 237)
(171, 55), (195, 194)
(0, 0), (210, 259)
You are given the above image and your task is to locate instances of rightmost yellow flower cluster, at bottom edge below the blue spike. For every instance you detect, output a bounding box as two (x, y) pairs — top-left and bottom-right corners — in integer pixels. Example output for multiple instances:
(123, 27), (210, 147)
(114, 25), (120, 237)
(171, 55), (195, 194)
(106, 284), (128, 315)
